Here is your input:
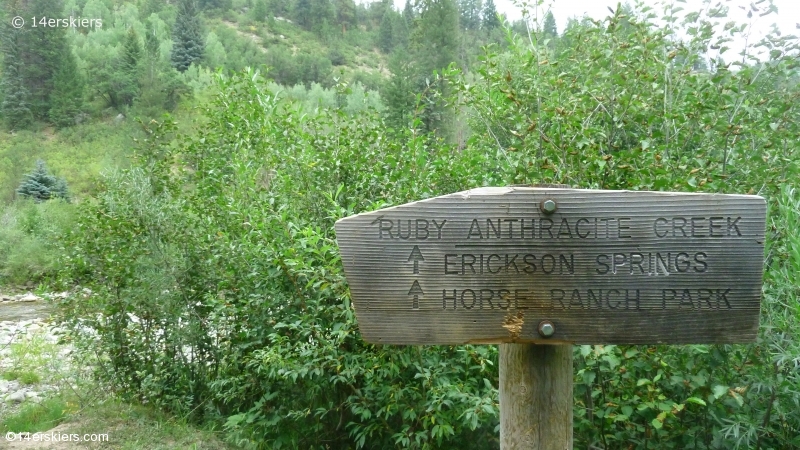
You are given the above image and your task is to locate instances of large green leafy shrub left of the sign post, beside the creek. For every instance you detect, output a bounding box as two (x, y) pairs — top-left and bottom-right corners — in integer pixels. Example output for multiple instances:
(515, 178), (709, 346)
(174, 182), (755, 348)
(62, 70), (497, 448)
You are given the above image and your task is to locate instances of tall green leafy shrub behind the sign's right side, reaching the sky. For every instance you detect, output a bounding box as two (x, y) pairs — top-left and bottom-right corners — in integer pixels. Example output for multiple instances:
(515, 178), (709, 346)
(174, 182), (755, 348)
(450, 1), (800, 449)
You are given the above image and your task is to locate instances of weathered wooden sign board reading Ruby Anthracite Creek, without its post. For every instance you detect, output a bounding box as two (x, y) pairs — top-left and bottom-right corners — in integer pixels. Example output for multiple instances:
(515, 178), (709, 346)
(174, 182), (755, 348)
(336, 187), (766, 344)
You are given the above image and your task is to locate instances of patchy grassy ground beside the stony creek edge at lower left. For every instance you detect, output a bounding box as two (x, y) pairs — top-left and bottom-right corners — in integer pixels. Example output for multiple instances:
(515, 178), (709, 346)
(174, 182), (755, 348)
(0, 310), (234, 450)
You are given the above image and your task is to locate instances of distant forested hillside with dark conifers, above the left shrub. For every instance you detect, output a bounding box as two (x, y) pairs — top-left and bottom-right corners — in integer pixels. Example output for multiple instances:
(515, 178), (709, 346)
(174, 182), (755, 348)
(0, 0), (503, 201)
